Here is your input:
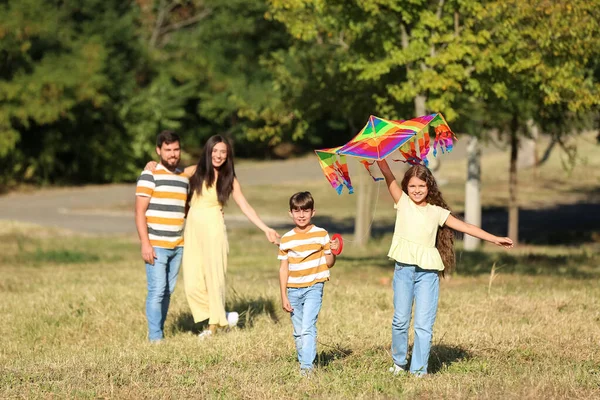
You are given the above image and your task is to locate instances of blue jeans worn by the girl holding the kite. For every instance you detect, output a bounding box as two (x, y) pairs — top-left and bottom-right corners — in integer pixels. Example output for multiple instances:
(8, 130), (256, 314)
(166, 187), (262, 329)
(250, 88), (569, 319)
(392, 262), (440, 375)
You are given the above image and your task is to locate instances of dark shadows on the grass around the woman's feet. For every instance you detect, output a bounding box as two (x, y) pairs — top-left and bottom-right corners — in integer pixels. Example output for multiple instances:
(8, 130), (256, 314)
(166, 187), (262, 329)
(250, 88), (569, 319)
(171, 294), (279, 334)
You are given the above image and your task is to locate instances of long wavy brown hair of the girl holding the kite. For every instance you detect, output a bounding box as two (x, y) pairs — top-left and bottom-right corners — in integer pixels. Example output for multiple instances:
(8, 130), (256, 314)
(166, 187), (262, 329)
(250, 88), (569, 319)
(401, 165), (456, 276)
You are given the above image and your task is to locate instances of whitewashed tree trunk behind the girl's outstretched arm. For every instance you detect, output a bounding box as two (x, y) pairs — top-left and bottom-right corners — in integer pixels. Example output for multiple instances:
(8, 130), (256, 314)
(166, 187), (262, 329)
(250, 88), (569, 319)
(464, 136), (481, 251)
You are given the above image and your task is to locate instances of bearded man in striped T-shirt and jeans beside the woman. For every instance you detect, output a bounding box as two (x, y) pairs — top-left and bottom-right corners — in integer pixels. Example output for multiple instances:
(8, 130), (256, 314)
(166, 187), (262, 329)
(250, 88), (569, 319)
(135, 131), (189, 342)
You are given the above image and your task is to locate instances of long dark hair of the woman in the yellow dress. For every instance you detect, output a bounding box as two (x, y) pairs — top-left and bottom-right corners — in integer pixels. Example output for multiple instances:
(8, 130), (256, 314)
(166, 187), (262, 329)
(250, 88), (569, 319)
(190, 135), (235, 204)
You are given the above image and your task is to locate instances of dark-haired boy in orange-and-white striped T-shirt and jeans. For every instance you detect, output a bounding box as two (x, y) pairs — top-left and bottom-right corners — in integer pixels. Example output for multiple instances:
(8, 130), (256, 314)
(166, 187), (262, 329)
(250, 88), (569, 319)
(277, 192), (337, 375)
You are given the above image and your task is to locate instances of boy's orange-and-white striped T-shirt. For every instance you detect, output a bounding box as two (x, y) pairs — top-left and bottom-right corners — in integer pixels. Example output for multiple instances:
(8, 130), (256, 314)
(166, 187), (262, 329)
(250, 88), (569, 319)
(277, 225), (331, 287)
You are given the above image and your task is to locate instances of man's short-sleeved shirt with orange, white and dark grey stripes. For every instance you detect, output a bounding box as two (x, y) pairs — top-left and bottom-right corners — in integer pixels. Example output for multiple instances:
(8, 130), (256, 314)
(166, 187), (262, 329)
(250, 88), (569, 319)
(135, 164), (189, 249)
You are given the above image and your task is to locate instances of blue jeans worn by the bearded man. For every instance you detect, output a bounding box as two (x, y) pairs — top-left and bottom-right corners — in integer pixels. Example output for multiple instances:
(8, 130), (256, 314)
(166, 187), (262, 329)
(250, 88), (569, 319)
(146, 246), (183, 341)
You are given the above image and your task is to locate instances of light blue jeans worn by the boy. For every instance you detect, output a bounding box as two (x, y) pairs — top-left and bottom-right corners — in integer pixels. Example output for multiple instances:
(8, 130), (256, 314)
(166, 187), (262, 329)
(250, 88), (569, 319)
(287, 282), (325, 369)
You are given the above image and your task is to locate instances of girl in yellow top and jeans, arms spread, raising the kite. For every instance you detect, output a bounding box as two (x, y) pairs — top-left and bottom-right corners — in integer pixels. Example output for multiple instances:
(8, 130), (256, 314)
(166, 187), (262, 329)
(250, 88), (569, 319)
(377, 160), (513, 376)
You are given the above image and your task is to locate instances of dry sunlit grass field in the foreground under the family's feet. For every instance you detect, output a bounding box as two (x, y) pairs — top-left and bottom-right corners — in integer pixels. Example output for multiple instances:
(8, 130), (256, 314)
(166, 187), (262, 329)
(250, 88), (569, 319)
(0, 223), (600, 399)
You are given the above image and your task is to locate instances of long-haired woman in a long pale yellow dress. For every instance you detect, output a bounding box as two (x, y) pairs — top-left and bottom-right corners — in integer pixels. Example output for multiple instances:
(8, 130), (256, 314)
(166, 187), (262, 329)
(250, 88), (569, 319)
(147, 135), (279, 339)
